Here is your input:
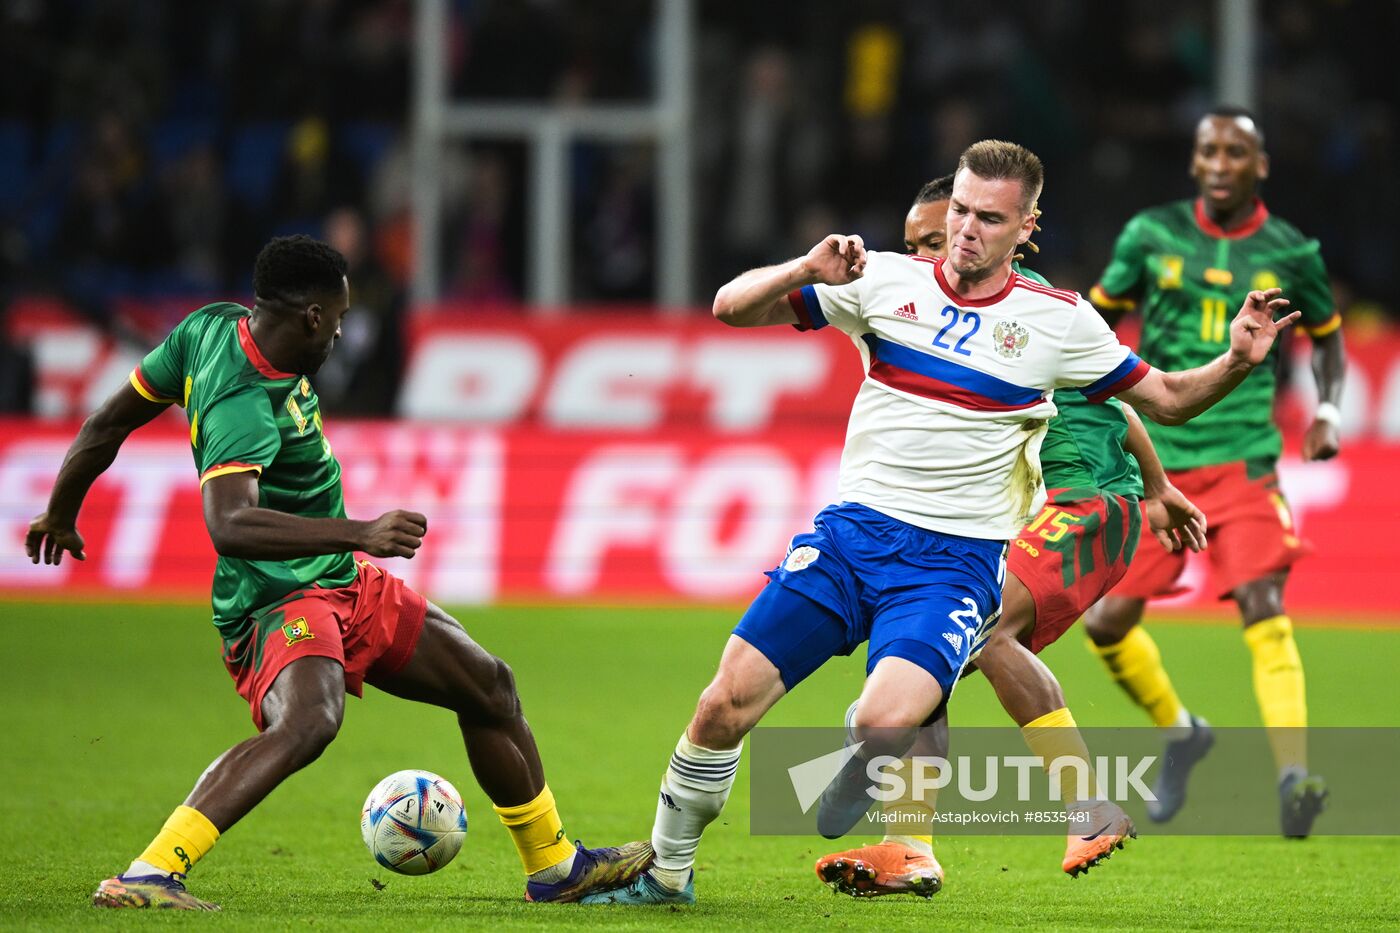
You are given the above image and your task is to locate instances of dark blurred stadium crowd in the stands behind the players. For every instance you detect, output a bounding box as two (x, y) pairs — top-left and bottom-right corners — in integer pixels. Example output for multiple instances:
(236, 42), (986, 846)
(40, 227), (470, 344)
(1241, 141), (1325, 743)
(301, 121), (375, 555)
(0, 0), (1400, 412)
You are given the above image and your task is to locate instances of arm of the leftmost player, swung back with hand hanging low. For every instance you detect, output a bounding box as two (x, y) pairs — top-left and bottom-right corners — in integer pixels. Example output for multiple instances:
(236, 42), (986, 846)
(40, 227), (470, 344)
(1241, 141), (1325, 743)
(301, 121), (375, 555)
(24, 382), (169, 565)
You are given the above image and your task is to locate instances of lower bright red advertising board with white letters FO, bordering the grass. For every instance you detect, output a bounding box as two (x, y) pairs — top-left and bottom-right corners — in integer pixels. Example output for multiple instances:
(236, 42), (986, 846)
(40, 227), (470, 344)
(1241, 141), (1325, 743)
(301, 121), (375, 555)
(0, 417), (1400, 619)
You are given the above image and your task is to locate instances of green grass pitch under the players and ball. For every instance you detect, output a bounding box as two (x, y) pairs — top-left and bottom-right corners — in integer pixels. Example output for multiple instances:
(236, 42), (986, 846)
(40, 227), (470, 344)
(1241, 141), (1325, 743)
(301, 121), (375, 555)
(0, 602), (1400, 930)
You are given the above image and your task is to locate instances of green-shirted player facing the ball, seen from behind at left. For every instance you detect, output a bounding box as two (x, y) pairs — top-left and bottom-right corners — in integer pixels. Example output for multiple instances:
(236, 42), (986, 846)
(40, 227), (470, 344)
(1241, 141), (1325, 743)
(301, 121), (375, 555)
(25, 237), (651, 911)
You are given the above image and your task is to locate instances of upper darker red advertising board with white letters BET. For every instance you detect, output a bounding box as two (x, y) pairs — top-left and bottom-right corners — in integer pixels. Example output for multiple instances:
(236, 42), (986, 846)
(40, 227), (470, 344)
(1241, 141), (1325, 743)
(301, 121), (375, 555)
(4, 298), (1400, 444)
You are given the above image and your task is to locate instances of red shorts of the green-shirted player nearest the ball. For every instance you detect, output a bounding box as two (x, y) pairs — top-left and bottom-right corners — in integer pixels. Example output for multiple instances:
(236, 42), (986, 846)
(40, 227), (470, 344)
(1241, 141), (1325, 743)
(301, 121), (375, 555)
(224, 560), (428, 731)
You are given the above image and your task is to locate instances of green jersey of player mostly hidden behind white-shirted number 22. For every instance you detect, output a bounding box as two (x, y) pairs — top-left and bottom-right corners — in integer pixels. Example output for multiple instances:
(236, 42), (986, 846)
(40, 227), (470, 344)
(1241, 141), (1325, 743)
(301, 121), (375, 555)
(1012, 263), (1142, 502)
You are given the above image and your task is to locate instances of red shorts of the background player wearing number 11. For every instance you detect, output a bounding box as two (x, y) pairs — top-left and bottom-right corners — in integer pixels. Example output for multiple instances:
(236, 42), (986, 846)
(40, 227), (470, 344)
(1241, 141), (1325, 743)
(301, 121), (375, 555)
(1116, 461), (1312, 600)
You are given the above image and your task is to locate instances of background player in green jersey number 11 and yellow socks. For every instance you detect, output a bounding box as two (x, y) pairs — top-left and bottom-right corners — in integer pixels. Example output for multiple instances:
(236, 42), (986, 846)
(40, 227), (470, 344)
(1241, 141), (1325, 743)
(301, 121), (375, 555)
(1085, 108), (1344, 836)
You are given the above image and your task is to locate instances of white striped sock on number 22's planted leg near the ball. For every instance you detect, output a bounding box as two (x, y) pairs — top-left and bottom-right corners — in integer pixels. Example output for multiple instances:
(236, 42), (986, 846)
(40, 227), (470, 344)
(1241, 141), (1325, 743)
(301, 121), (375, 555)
(651, 733), (743, 891)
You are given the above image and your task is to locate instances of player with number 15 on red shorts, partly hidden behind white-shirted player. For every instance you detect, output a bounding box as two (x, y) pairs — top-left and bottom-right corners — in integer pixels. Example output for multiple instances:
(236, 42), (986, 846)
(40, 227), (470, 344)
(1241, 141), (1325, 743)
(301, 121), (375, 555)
(816, 175), (1205, 897)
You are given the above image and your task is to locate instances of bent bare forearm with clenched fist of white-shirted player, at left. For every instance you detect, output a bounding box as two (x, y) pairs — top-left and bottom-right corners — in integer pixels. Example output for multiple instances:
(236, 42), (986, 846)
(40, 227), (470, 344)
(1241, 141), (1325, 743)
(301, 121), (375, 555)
(713, 234), (865, 328)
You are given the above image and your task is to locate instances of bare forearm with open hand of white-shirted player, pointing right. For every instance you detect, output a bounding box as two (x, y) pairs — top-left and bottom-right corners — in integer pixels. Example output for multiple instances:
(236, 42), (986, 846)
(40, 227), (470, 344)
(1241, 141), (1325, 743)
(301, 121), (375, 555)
(1119, 289), (1299, 424)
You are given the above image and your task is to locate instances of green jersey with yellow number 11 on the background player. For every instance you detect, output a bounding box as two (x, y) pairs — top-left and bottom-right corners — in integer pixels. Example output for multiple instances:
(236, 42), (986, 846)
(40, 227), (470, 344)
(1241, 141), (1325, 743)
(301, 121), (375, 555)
(1091, 200), (1341, 469)
